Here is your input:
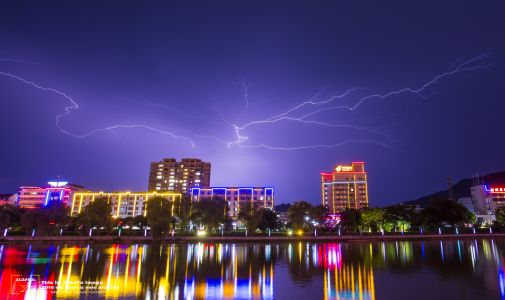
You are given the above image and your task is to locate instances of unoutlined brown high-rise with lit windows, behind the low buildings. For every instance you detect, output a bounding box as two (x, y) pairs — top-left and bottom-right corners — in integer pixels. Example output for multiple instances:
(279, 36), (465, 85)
(148, 158), (210, 193)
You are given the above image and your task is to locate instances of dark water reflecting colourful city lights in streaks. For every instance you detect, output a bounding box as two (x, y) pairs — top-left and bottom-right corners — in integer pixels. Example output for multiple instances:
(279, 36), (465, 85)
(0, 240), (505, 300)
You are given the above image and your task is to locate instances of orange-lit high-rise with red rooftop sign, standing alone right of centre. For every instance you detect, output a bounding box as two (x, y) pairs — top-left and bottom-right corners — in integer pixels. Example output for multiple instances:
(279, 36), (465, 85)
(321, 162), (368, 214)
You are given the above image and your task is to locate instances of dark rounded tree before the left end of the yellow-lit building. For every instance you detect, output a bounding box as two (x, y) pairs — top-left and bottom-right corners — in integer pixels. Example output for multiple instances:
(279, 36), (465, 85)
(77, 197), (113, 234)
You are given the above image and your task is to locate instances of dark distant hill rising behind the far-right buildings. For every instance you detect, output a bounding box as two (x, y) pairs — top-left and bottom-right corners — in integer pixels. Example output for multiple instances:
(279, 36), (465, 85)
(403, 172), (505, 206)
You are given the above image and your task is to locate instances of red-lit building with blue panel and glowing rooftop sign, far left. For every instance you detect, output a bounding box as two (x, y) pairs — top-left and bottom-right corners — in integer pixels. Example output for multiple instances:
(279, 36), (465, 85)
(18, 181), (84, 209)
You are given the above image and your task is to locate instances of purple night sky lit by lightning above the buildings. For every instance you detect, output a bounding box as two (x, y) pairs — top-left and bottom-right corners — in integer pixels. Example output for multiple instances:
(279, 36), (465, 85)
(0, 1), (505, 206)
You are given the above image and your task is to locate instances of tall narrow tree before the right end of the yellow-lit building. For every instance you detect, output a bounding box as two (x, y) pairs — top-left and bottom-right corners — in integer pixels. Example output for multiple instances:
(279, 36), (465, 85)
(147, 197), (173, 237)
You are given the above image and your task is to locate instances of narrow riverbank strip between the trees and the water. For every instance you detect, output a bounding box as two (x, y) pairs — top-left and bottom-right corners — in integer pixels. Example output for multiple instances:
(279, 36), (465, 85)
(0, 233), (505, 244)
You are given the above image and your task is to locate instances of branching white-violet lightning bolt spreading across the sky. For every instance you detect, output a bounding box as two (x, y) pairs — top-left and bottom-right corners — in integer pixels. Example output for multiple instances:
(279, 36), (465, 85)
(0, 53), (497, 151)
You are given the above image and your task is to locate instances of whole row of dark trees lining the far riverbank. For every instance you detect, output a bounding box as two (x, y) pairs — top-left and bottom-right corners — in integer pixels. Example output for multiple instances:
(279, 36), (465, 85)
(0, 197), (496, 237)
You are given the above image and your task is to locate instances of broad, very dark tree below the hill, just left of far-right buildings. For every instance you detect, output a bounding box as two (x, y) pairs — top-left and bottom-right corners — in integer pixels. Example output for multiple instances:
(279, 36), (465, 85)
(421, 198), (475, 228)
